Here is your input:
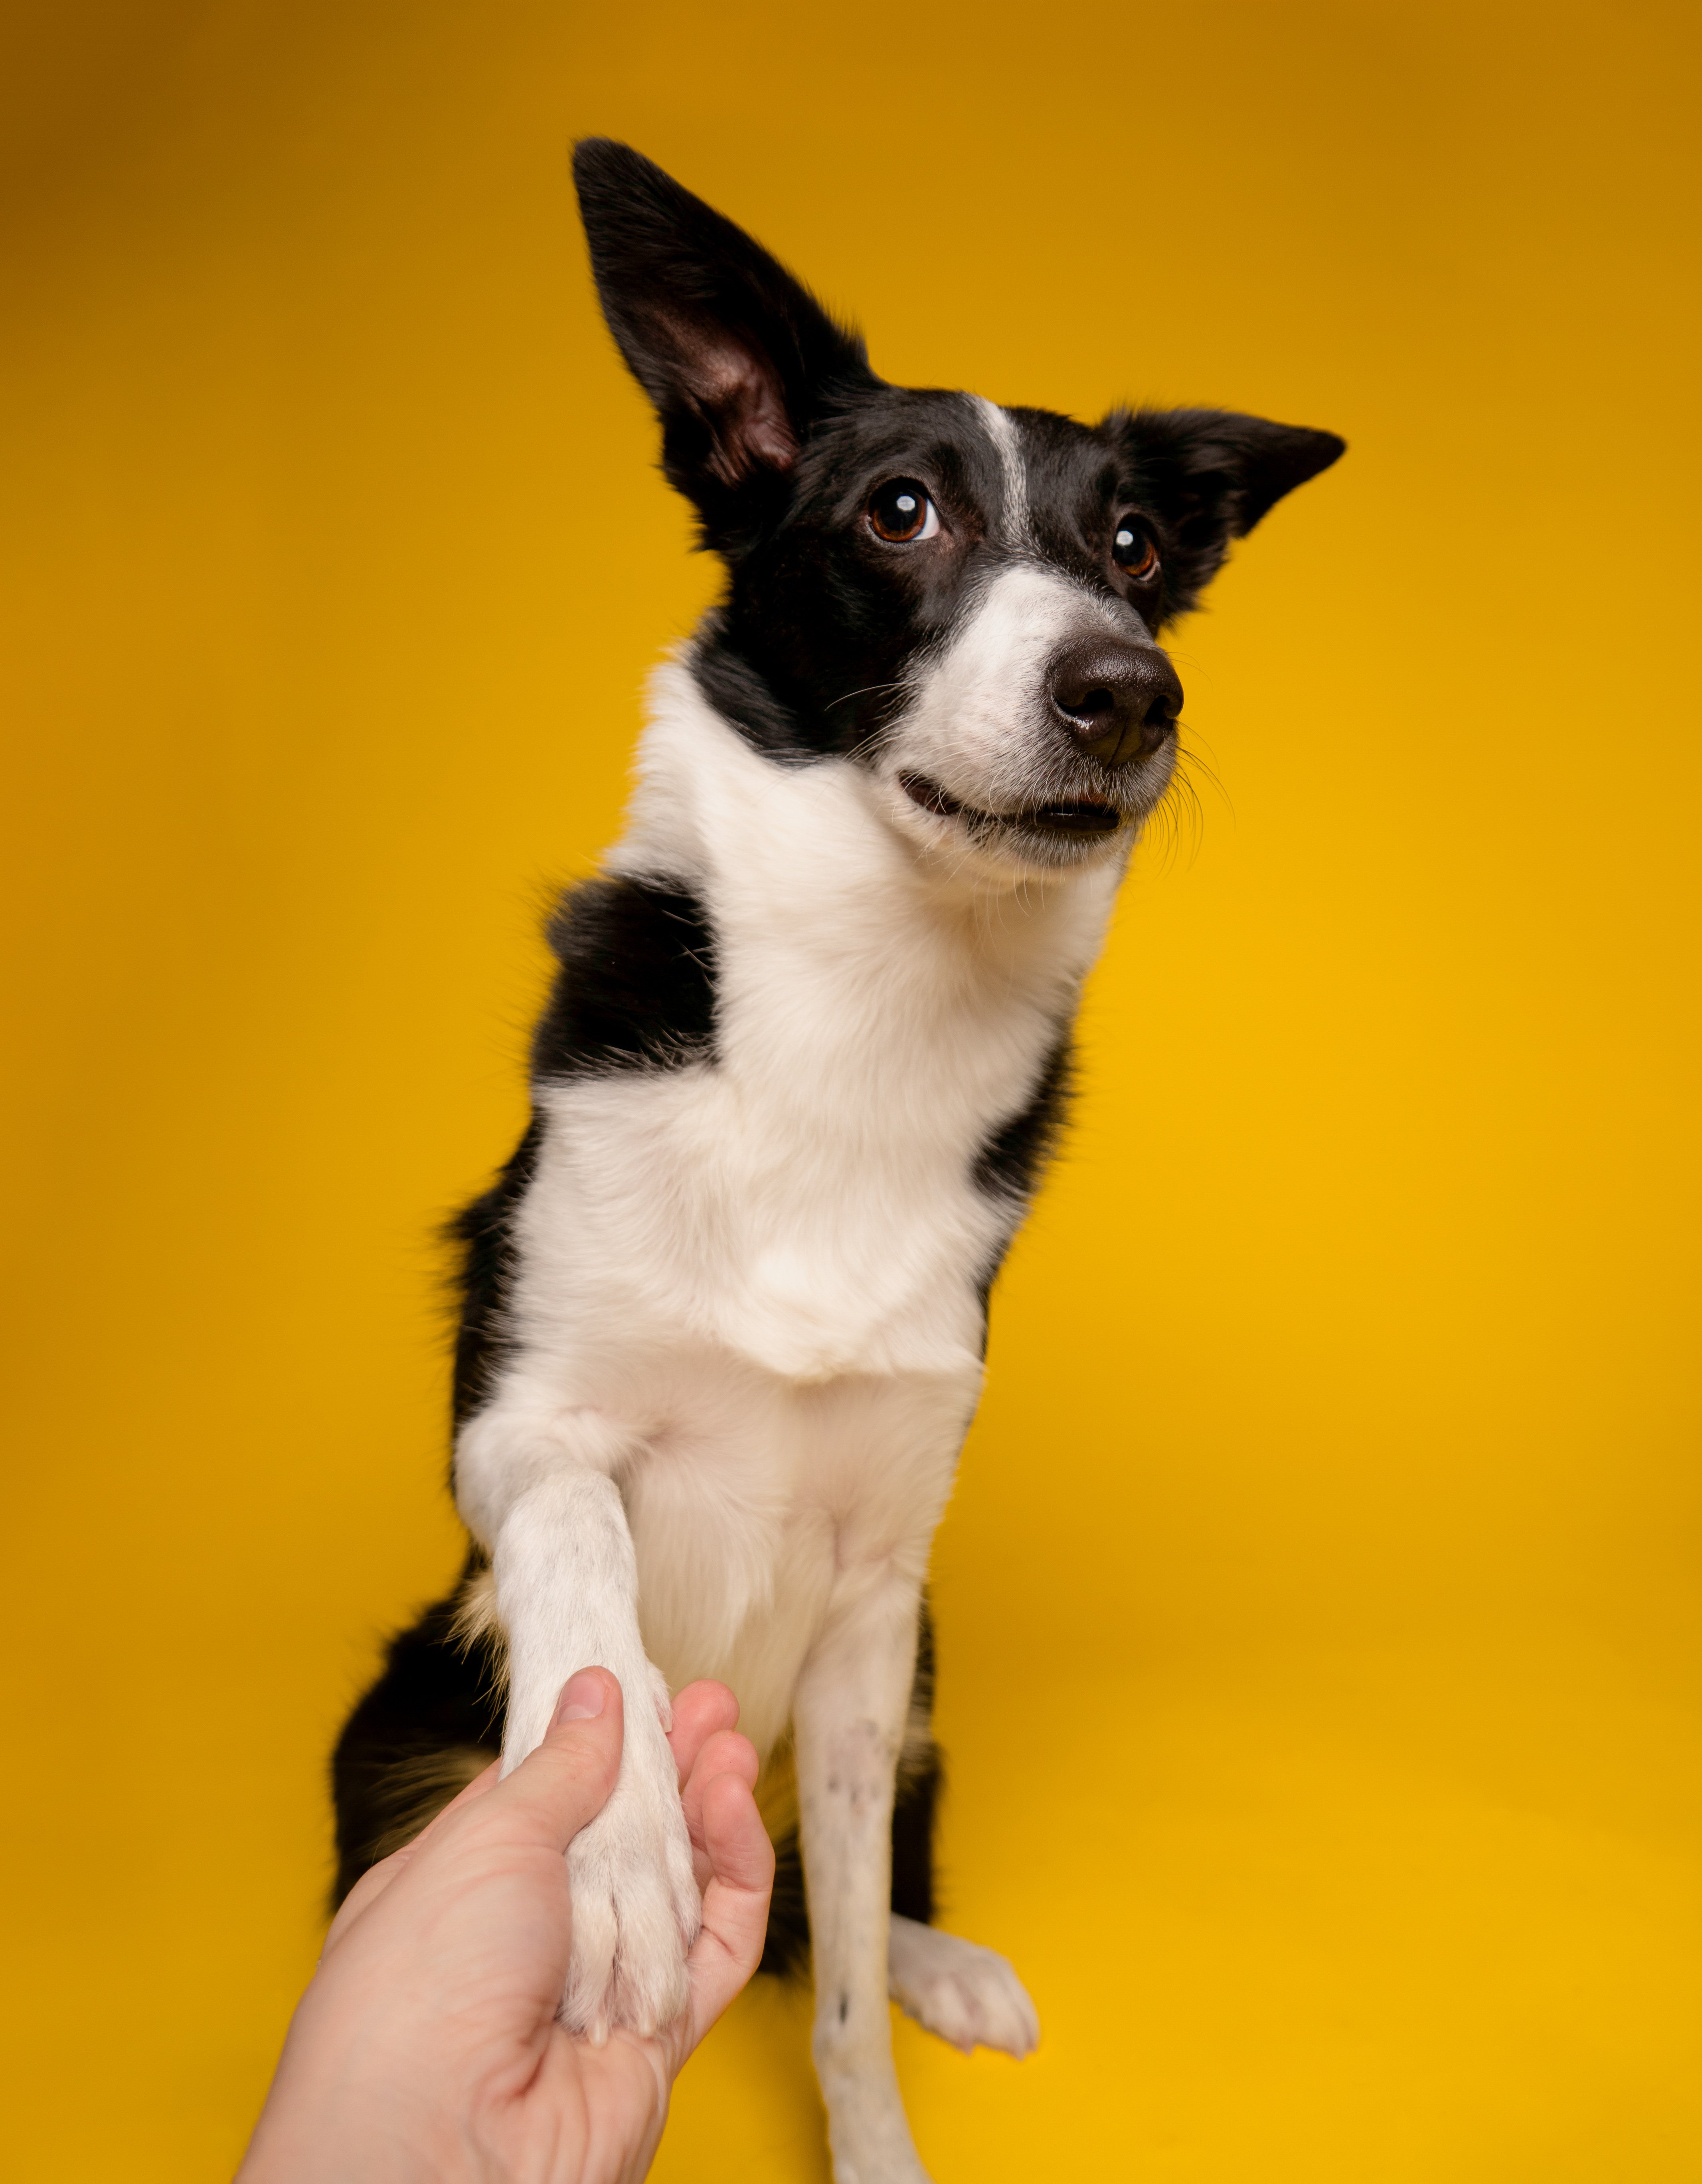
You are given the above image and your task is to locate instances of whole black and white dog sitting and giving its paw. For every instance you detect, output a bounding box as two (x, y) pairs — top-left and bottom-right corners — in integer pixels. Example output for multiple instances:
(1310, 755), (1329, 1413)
(334, 142), (1342, 2184)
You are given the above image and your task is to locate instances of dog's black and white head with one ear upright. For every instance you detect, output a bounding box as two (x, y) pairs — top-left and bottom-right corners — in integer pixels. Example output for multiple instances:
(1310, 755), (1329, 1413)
(575, 140), (1344, 874)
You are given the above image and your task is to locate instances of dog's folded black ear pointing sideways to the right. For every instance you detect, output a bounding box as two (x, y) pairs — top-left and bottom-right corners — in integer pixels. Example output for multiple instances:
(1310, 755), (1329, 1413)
(1103, 411), (1348, 616)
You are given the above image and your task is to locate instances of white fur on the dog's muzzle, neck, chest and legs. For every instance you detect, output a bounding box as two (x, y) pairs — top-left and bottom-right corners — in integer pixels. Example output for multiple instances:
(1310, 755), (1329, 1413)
(457, 434), (1130, 2184)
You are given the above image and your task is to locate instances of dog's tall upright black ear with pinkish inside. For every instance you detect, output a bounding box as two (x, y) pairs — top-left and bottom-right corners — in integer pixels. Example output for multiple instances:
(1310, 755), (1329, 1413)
(572, 138), (878, 544)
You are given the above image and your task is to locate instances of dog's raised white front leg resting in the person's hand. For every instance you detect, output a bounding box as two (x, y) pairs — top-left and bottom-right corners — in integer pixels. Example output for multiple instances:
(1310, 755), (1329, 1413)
(457, 1407), (701, 2044)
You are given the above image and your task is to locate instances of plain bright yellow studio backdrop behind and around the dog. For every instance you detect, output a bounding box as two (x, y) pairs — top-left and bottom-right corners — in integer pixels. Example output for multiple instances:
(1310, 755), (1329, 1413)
(0, 0), (1702, 2184)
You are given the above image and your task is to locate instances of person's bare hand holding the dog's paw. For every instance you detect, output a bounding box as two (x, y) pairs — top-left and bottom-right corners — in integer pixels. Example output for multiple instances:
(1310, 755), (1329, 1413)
(238, 1669), (773, 2184)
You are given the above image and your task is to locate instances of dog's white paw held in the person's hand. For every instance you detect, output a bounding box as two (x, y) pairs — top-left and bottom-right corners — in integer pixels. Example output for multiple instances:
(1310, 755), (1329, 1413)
(561, 1699), (704, 2046)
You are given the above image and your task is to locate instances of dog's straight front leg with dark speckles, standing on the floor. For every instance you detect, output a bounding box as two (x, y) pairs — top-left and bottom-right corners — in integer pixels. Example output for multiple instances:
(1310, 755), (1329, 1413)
(793, 1570), (926, 2184)
